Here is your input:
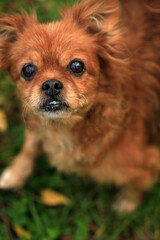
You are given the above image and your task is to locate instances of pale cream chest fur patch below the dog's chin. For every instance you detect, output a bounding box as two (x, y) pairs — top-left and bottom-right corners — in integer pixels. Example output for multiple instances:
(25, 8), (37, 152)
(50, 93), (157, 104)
(41, 129), (91, 171)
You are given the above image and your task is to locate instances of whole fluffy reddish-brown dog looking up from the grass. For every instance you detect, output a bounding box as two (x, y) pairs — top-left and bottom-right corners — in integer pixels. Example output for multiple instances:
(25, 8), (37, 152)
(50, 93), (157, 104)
(0, 0), (160, 212)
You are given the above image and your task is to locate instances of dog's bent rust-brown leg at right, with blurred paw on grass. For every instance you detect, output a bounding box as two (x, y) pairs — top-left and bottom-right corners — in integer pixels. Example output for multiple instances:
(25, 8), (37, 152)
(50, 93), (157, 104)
(113, 144), (159, 213)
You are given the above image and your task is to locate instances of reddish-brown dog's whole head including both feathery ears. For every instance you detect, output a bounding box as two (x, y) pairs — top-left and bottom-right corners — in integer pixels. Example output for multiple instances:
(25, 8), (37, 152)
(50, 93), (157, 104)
(0, 0), (118, 123)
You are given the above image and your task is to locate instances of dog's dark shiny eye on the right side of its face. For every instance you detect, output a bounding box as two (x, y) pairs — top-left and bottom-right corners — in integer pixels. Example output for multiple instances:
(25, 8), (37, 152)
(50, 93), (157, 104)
(69, 59), (86, 76)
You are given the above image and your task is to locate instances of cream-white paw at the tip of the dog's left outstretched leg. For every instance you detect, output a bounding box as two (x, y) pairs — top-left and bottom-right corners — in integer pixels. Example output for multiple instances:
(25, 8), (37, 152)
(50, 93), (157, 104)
(0, 167), (24, 189)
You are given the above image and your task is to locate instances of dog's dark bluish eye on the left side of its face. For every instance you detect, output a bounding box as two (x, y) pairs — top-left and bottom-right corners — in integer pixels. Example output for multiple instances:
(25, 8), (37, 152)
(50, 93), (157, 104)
(21, 63), (37, 81)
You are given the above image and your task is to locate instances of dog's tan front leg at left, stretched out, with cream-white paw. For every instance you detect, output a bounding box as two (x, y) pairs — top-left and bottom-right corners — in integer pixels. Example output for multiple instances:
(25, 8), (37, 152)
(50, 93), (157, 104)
(0, 130), (40, 189)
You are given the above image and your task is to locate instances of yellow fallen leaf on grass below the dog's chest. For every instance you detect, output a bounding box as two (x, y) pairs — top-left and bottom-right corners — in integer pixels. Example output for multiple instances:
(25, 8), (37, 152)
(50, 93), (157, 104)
(41, 189), (70, 206)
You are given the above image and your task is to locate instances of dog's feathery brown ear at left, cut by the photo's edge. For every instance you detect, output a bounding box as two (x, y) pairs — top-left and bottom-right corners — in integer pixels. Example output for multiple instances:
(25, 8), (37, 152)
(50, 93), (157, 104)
(0, 10), (37, 70)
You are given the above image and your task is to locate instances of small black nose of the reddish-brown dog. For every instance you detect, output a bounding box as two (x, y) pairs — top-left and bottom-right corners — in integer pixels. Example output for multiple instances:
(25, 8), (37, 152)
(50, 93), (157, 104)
(42, 79), (63, 96)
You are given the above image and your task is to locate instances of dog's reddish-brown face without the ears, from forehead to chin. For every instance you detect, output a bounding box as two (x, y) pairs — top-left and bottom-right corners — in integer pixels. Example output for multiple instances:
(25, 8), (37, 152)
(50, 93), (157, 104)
(11, 22), (99, 118)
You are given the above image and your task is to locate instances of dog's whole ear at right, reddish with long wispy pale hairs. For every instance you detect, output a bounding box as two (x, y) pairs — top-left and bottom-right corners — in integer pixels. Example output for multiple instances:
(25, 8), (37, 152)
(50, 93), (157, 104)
(60, 0), (126, 61)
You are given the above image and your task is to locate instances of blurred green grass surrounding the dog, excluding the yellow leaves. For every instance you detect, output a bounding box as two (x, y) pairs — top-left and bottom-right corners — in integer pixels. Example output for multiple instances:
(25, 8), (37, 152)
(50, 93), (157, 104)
(0, 0), (160, 240)
